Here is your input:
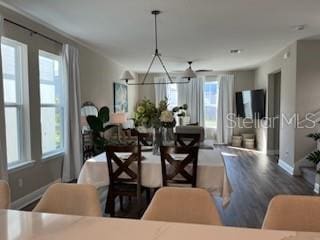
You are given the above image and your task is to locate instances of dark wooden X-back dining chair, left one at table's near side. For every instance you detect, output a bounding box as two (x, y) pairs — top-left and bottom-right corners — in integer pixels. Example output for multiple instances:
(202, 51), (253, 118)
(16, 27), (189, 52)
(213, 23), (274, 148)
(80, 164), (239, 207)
(105, 145), (149, 217)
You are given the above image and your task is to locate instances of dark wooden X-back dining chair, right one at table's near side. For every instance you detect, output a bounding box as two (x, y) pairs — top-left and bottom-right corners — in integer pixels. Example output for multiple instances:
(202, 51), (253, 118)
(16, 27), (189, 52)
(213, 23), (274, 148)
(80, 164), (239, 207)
(160, 146), (199, 187)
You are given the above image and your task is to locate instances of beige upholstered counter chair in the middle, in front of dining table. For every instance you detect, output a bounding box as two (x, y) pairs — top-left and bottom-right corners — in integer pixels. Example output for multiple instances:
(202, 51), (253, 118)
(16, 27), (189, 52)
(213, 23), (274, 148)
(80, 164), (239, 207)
(142, 187), (222, 225)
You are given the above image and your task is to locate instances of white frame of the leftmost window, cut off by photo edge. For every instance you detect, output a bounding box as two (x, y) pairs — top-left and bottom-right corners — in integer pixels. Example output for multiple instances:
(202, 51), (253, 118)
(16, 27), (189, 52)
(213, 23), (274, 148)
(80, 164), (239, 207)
(1, 37), (28, 170)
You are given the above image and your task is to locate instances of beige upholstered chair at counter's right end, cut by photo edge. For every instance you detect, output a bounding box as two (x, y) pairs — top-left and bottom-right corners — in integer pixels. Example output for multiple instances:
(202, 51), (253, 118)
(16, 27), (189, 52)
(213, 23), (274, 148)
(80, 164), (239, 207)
(262, 195), (320, 232)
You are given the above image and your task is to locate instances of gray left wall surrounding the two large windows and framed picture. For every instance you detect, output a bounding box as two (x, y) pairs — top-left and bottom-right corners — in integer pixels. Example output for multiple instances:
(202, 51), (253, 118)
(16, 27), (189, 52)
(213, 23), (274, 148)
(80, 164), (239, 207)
(0, 6), (137, 201)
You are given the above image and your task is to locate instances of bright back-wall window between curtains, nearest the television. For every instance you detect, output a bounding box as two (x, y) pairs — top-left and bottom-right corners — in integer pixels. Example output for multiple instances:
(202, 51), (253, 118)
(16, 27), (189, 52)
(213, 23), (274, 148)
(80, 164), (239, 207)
(204, 80), (219, 128)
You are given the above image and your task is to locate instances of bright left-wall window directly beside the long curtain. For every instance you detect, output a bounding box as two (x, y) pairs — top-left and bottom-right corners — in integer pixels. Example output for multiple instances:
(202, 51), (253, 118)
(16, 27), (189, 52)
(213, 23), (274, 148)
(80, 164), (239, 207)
(39, 51), (64, 158)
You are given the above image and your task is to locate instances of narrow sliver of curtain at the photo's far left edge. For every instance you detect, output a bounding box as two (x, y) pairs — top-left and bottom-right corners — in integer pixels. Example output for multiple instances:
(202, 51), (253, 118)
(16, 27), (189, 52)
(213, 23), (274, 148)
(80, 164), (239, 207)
(0, 16), (8, 180)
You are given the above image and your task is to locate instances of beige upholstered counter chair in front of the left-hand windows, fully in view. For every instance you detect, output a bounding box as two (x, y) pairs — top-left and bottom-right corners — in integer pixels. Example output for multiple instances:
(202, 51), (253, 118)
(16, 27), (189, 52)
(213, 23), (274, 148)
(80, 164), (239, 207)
(33, 183), (101, 216)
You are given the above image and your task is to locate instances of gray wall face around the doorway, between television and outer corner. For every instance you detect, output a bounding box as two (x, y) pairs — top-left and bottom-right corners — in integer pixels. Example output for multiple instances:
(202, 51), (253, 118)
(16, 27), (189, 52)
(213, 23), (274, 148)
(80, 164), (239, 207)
(255, 43), (297, 169)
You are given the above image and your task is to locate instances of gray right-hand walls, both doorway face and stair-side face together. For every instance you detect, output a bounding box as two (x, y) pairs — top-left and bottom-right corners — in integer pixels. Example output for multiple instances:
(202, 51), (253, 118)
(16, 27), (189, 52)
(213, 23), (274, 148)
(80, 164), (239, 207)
(255, 40), (320, 168)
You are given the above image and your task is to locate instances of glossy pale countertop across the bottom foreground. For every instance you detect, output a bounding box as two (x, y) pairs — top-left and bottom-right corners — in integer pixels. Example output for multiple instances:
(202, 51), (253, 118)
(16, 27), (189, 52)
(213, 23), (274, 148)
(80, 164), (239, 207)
(0, 210), (320, 240)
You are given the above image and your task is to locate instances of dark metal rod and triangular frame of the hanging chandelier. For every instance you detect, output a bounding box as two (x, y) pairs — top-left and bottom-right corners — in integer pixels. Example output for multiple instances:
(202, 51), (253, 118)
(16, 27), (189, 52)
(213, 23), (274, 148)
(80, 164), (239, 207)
(126, 10), (189, 85)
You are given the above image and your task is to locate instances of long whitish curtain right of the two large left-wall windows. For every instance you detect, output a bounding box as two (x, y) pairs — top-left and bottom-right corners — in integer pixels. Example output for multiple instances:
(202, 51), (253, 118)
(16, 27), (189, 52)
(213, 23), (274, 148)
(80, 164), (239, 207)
(62, 44), (82, 182)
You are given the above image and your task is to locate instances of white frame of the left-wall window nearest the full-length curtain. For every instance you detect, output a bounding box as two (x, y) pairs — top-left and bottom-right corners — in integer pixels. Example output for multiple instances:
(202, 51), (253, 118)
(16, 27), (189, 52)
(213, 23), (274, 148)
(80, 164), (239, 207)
(38, 49), (65, 160)
